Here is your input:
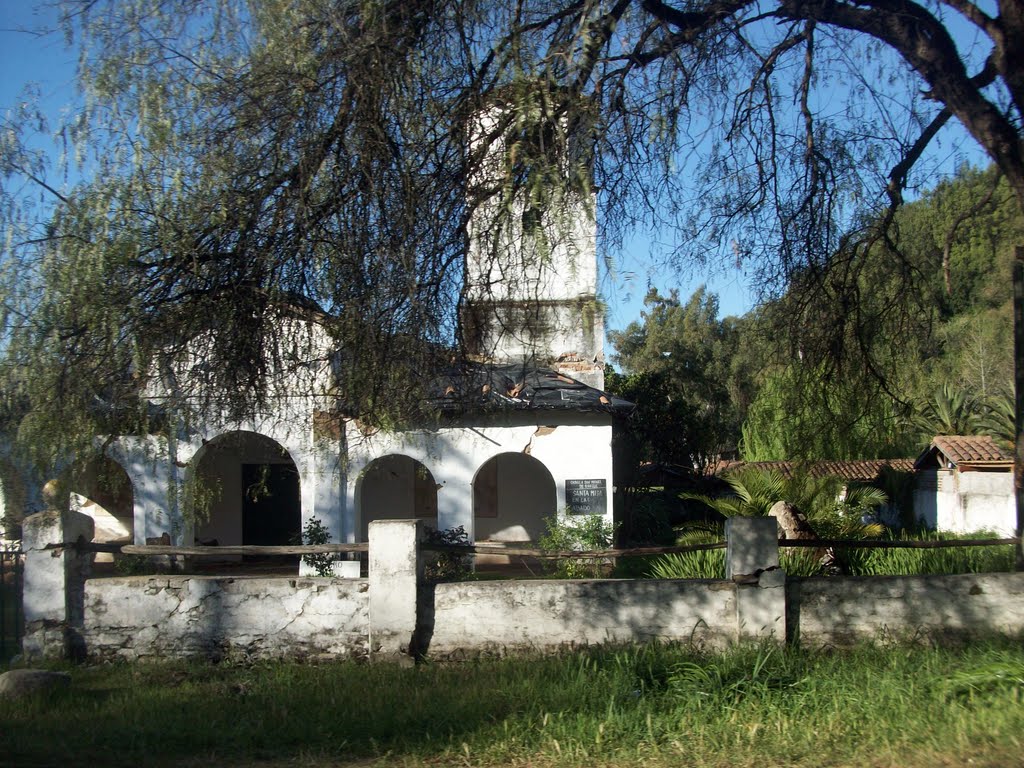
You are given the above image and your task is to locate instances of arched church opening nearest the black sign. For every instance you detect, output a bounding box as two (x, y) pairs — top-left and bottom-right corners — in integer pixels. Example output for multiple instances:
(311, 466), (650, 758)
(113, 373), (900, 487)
(473, 454), (558, 542)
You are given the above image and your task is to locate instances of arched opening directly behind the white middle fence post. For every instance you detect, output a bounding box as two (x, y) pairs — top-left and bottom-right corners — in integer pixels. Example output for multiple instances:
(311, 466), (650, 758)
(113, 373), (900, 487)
(356, 455), (437, 542)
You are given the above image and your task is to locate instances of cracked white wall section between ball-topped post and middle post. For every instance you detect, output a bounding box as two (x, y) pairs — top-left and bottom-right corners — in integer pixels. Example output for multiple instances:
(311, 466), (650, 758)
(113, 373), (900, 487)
(82, 575), (370, 659)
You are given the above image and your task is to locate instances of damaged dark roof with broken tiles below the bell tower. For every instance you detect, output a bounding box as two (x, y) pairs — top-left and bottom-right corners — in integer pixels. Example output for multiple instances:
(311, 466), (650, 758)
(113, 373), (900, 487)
(429, 361), (636, 415)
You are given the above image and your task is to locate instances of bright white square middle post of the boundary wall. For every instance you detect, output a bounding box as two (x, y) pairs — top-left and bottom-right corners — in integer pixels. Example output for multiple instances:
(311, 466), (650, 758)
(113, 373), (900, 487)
(369, 520), (423, 664)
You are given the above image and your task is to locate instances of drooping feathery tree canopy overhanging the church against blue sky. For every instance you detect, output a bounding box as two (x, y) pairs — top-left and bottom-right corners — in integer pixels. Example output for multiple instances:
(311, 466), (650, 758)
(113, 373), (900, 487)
(0, 0), (1024, 462)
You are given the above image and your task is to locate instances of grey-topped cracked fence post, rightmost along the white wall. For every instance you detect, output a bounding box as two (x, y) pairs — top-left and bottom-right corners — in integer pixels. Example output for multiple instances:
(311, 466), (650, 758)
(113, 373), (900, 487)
(725, 517), (785, 642)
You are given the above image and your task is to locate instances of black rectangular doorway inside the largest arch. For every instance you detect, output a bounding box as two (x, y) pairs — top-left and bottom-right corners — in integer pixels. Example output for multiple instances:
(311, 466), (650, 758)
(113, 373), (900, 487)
(242, 464), (302, 546)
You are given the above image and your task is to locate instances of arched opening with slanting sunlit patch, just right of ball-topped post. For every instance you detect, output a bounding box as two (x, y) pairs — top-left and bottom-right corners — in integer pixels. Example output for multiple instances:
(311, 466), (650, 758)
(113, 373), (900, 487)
(71, 457), (135, 562)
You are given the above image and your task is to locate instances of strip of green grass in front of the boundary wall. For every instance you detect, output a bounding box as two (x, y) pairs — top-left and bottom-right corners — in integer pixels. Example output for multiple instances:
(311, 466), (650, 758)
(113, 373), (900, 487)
(0, 639), (1024, 767)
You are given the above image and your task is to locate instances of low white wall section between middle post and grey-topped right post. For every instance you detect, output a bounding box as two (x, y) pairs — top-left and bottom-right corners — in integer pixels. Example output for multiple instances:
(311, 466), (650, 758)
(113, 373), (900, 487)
(421, 580), (737, 657)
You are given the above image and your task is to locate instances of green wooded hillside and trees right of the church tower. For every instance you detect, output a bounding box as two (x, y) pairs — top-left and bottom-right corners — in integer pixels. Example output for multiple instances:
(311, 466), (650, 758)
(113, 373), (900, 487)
(608, 167), (1024, 469)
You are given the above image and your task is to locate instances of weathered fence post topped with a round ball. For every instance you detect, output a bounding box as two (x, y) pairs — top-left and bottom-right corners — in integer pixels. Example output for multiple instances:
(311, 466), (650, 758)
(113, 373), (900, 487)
(22, 480), (95, 659)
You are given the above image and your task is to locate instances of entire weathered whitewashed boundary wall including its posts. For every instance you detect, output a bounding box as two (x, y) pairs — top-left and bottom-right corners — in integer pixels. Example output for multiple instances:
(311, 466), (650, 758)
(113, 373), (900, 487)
(18, 509), (1024, 662)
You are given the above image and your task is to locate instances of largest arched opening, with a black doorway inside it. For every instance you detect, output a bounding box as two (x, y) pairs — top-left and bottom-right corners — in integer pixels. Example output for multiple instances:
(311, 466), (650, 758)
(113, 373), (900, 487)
(186, 431), (302, 546)
